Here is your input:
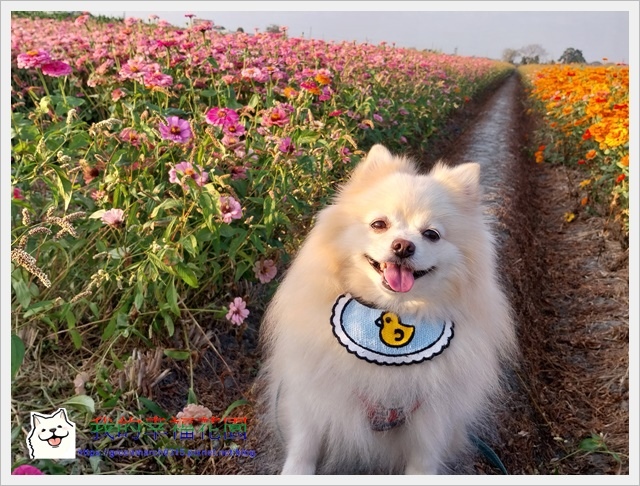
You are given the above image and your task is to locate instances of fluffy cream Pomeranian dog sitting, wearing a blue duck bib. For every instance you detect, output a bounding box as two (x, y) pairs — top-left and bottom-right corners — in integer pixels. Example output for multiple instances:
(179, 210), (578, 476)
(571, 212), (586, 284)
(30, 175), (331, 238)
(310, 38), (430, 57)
(261, 145), (516, 474)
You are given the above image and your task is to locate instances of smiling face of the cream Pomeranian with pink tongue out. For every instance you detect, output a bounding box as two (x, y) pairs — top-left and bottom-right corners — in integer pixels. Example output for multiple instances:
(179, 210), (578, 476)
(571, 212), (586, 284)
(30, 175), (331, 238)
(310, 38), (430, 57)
(319, 146), (481, 312)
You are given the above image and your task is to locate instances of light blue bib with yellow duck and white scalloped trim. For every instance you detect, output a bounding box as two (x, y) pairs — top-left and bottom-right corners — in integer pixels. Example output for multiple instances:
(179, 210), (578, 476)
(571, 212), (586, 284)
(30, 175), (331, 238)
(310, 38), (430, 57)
(331, 294), (453, 365)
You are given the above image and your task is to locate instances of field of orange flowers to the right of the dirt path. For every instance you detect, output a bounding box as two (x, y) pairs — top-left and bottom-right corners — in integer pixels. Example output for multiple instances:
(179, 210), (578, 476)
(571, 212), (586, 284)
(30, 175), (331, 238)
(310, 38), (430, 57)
(528, 65), (629, 235)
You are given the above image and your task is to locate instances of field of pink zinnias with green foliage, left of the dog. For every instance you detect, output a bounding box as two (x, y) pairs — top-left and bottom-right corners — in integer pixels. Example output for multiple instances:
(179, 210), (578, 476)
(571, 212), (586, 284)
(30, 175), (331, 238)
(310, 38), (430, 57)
(11, 11), (516, 472)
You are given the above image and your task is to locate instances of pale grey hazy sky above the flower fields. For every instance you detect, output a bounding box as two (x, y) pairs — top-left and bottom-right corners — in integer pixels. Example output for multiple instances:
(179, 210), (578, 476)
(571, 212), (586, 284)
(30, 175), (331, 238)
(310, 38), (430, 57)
(86, 1), (634, 62)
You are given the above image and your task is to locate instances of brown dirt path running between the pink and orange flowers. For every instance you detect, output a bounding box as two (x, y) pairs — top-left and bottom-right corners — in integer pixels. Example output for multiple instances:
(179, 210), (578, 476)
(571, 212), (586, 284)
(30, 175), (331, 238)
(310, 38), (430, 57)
(430, 76), (629, 474)
